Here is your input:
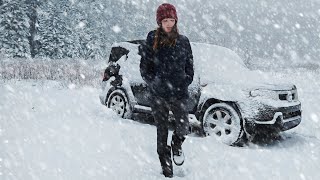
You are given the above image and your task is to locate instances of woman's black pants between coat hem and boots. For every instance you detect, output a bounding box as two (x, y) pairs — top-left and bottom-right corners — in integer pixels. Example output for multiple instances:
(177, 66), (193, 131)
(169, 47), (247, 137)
(151, 96), (189, 156)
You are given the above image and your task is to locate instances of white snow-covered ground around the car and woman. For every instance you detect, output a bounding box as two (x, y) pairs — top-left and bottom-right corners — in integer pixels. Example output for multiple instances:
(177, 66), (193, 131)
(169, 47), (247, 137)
(0, 70), (320, 180)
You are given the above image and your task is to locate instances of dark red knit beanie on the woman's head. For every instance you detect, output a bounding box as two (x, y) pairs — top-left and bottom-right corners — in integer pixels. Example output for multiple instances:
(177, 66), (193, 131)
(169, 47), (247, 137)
(157, 3), (178, 26)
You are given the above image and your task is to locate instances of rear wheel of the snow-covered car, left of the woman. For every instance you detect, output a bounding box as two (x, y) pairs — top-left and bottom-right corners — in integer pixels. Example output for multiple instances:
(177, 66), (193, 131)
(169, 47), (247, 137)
(106, 89), (132, 118)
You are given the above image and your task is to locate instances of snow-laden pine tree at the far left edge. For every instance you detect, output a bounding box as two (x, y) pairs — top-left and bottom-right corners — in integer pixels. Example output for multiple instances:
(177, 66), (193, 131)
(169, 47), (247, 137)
(0, 0), (30, 57)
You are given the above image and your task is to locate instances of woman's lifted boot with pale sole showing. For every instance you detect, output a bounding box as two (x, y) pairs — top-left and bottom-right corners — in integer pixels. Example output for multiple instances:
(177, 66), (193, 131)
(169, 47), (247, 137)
(171, 134), (185, 166)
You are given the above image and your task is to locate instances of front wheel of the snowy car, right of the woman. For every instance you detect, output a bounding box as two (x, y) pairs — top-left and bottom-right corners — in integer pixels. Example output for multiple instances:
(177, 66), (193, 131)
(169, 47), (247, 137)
(201, 103), (243, 145)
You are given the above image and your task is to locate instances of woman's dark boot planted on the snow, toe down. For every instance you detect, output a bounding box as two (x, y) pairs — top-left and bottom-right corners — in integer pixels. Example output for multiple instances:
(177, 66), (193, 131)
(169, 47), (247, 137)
(158, 146), (173, 178)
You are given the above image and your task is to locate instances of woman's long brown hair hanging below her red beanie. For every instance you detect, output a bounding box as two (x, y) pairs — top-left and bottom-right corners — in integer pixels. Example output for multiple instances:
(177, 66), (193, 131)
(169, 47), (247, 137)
(153, 23), (179, 50)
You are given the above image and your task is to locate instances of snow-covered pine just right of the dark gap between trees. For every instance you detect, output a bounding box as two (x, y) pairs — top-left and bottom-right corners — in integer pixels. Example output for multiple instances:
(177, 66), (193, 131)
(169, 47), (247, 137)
(37, 0), (79, 59)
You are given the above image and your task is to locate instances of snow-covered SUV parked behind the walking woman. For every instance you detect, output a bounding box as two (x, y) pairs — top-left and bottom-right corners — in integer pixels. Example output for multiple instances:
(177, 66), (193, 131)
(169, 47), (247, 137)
(100, 40), (301, 145)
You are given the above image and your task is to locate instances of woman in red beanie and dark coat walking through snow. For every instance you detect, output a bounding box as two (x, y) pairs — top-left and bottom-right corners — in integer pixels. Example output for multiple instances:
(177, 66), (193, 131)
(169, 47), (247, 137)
(139, 3), (194, 177)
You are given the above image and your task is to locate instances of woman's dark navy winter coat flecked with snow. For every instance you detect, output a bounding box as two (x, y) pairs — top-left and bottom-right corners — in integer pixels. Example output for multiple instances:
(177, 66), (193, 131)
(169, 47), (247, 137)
(139, 31), (194, 99)
